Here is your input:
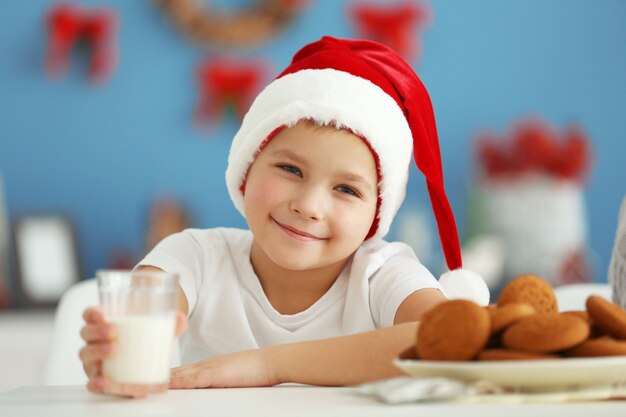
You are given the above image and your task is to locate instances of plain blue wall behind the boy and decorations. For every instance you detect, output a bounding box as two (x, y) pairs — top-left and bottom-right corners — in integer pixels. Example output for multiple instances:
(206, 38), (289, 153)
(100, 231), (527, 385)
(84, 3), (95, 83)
(0, 0), (626, 281)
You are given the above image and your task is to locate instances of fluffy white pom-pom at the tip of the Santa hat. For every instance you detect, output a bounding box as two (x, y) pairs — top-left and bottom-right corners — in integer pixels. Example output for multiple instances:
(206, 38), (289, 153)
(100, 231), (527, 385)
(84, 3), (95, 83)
(439, 269), (489, 306)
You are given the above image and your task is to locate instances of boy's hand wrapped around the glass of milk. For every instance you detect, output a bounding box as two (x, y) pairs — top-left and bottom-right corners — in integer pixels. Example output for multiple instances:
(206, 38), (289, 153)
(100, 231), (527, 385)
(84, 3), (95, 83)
(79, 307), (187, 398)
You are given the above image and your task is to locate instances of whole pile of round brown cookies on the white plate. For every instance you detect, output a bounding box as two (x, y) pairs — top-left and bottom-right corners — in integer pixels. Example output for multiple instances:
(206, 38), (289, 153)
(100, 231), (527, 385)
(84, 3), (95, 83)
(416, 275), (626, 361)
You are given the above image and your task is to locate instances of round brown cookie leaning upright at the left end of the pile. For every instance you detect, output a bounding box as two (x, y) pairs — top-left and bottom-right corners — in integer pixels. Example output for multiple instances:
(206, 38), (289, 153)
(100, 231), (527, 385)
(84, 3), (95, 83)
(417, 300), (490, 361)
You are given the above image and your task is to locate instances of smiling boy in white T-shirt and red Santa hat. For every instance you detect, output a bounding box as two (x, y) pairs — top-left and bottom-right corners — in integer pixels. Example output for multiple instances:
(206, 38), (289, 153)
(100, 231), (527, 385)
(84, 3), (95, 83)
(81, 37), (489, 396)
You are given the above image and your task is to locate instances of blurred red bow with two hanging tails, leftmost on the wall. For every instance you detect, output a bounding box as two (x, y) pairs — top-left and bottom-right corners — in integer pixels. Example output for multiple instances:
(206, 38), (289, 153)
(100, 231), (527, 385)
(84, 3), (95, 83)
(45, 3), (118, 81)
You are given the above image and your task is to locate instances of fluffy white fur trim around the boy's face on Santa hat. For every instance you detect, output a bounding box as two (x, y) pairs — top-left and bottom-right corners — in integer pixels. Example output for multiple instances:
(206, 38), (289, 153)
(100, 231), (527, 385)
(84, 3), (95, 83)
(226, 69), (413, 238)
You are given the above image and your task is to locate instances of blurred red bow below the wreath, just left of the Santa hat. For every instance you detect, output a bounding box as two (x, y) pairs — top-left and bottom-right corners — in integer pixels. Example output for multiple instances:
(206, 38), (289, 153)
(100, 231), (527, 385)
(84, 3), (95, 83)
(195, 58), (266, 127)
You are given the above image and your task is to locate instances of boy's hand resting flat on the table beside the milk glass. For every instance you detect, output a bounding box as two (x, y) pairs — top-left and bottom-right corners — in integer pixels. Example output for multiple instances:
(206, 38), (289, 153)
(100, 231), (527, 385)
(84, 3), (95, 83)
(170, 348), (281, 389)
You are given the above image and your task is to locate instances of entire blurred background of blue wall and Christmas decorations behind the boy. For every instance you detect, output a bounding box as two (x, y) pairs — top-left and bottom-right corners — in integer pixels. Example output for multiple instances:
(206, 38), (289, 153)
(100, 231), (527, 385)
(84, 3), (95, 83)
(0, 0), (626, 390)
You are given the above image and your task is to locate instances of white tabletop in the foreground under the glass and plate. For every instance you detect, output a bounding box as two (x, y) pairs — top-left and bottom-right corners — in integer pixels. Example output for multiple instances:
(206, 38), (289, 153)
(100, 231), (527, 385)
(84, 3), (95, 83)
(0, 385), (626, 417)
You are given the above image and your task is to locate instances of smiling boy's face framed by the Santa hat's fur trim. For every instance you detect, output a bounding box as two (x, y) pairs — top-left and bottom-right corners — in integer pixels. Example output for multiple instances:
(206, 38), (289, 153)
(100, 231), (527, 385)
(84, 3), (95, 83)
(244, 122), (378, 270)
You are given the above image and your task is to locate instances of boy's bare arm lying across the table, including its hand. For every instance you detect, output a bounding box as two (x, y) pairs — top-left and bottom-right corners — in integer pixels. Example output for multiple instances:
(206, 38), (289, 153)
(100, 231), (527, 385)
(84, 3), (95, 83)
(171, 290), (445, 388)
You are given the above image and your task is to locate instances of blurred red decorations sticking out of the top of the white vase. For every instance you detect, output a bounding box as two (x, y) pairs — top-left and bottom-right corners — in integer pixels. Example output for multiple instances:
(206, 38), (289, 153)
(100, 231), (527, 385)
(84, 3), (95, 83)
(476, 120), (591, 181)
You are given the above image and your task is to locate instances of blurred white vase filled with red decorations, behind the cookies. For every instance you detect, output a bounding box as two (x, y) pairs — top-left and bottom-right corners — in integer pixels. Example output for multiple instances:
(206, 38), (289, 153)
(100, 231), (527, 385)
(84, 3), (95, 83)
(472, 119), (592, 285)
